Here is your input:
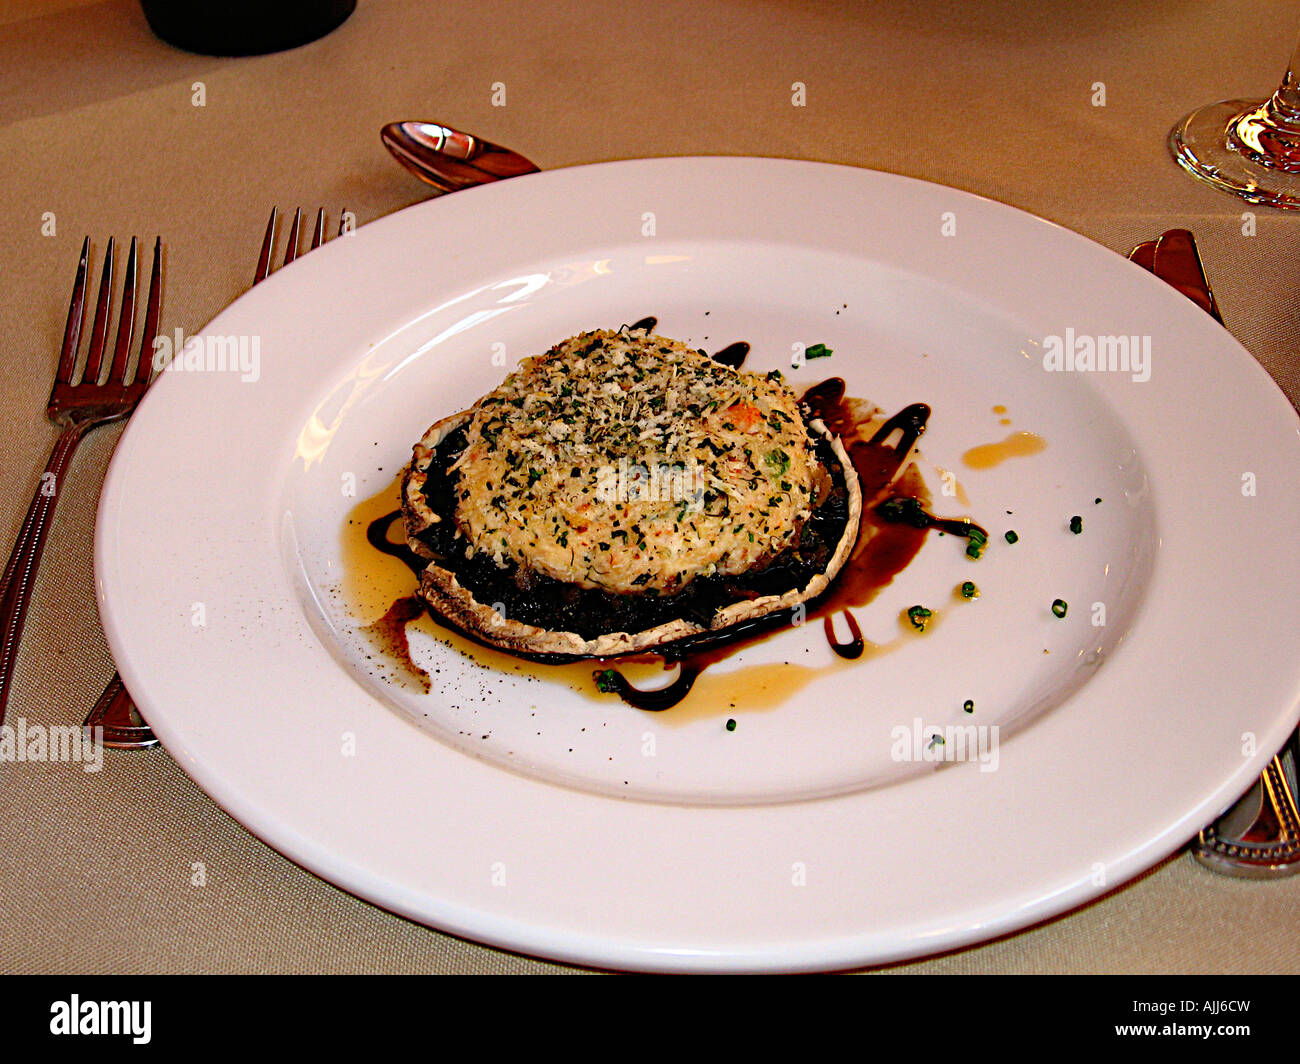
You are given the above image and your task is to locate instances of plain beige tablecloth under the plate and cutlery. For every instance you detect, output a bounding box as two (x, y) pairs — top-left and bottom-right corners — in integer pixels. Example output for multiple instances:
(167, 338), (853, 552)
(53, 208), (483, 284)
(0, 0), (1300, 973)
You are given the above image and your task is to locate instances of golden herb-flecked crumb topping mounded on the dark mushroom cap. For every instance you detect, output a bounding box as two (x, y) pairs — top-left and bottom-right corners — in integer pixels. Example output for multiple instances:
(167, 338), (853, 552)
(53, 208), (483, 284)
(451, 329), (819, 593)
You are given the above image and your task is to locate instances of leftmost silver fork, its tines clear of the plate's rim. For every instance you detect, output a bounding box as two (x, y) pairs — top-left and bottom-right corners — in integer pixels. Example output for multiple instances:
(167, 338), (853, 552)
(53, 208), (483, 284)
(0, 237), (163, 722)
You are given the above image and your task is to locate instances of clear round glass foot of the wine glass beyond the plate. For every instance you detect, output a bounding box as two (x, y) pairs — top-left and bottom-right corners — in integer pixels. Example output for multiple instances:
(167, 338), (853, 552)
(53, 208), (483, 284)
(1169, 100), (1300, 211)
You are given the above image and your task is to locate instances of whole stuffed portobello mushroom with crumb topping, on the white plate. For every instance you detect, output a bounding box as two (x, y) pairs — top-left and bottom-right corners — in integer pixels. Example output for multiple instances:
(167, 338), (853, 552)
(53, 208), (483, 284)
(402, 329), (862, 659)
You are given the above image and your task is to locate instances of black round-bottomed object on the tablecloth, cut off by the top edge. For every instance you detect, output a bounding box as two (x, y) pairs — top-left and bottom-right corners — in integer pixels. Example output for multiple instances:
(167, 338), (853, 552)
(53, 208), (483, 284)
(140, 0), (356, 56)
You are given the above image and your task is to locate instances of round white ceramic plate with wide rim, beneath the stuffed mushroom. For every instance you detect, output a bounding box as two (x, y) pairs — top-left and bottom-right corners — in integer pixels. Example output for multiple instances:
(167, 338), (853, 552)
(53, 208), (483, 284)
(96, 159), (1300, 969)
